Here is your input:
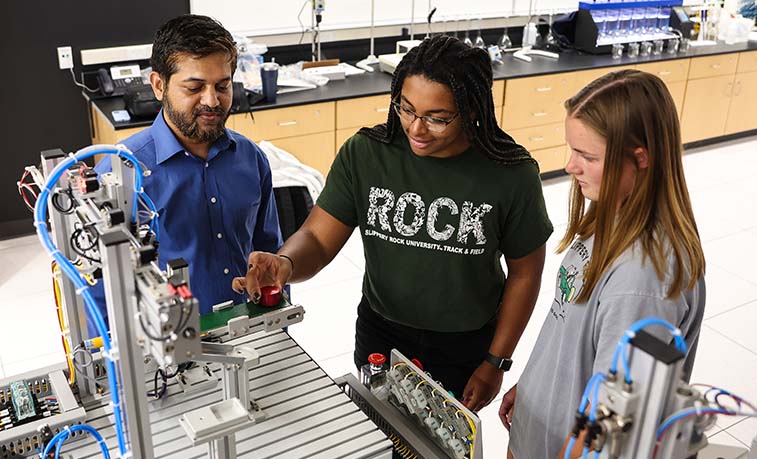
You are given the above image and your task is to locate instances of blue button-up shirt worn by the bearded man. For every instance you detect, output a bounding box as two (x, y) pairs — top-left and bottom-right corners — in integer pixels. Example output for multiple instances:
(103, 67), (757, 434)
(95, 111), (282, 314)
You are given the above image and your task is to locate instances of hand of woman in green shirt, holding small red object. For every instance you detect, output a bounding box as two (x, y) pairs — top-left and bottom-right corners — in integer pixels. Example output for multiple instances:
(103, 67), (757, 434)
(231, 252), (293, 303)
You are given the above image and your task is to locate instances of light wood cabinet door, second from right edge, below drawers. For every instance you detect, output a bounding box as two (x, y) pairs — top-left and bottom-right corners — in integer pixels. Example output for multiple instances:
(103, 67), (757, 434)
(681, 74), (735, 143)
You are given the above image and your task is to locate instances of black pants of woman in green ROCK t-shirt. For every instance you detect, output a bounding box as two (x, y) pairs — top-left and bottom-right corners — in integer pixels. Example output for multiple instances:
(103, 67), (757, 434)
(354, 297), (497, 398)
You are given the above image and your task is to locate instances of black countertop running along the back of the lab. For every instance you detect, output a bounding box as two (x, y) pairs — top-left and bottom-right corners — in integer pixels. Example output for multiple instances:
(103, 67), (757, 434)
(93, 41), (757, 130)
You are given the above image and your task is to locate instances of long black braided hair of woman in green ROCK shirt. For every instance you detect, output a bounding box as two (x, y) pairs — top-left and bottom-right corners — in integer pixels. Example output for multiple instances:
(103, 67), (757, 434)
(360, 35), (535, 165)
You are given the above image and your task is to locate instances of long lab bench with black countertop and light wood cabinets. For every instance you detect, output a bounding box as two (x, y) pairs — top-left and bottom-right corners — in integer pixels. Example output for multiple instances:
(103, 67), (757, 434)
(90, 42), (757, 175)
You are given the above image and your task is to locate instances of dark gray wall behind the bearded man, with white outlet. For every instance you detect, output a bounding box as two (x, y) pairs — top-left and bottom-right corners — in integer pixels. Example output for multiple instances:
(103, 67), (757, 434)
(0, 0), (189, 238)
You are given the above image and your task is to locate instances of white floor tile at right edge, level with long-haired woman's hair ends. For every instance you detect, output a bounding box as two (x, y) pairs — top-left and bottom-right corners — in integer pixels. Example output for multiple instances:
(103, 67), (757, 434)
(704, 263), (757, 320)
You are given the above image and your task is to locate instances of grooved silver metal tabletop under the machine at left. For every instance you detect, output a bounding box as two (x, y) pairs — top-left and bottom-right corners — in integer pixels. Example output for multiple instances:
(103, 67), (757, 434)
(57, 331), (392, 459)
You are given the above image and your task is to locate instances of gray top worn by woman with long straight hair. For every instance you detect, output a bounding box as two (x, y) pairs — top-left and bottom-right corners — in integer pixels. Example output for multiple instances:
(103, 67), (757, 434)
(510, 236), (705, 459)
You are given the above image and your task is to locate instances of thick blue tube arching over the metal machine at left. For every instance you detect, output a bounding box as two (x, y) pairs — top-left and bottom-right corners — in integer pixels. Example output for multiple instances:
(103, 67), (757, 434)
(34, 145), (149, 456)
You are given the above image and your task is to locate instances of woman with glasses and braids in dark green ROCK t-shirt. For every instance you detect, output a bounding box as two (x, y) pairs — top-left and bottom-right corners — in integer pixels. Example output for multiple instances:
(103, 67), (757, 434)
(233, 36), (552, 410)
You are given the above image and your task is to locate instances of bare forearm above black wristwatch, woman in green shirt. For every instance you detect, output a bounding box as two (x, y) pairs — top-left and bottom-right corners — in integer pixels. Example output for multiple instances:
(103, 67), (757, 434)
(489, 275), (541, 357)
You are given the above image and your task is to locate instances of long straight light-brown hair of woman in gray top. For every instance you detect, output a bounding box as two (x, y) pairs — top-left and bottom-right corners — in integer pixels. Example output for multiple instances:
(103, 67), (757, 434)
(558, 70), (705, 303)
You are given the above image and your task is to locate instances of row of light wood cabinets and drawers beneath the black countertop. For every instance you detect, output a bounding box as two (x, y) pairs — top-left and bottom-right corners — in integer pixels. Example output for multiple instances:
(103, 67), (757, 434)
(92, 51), (757, 175)
